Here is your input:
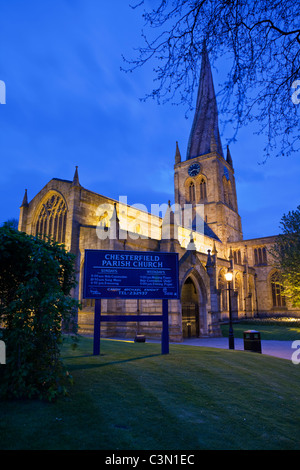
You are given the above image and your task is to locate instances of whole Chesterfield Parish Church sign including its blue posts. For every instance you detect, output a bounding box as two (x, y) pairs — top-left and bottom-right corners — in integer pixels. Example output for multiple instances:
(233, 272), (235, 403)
(83, 250), (179, 355)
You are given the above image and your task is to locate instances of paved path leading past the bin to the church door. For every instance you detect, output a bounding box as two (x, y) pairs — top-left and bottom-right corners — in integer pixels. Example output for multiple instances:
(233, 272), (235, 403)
(176, 338), (295, 360)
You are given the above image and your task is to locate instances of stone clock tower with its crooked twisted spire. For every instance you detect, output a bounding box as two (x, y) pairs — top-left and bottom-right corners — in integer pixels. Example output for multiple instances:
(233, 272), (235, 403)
(174, 44), (243, 244)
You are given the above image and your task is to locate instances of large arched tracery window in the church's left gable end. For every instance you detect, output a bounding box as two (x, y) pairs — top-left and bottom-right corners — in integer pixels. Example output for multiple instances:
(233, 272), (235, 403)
(35, 194), (67, 243)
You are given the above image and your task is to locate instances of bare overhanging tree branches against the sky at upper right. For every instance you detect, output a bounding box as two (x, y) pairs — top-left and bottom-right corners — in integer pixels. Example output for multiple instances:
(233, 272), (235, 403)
(124, 0), (300, 157)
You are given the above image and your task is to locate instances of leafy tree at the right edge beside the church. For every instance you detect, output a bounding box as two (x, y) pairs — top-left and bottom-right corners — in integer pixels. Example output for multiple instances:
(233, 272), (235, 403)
(271, 206), (300, 307)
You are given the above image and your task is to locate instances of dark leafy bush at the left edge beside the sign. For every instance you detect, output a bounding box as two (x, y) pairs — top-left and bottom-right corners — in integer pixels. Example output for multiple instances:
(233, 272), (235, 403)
(0, 226), (78, 400)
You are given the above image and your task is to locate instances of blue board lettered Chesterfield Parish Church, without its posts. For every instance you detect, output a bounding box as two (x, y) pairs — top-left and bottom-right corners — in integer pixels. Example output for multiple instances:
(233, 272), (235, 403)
(83, 250), (179, 299)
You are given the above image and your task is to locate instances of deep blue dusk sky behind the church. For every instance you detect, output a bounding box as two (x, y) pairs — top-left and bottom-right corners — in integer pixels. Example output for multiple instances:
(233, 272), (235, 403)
(0, 0), (300, 238)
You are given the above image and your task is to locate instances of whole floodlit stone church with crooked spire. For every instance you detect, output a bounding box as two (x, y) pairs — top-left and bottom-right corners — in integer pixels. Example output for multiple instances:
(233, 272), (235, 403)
(19, 46), (300, 342)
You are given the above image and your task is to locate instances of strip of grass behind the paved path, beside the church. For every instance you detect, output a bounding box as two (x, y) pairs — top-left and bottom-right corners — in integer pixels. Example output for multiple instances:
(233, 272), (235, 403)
(221, 320), (300, 341)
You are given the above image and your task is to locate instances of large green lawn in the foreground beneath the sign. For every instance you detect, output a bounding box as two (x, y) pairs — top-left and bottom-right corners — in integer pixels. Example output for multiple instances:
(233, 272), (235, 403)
(0, 338), (300, 450)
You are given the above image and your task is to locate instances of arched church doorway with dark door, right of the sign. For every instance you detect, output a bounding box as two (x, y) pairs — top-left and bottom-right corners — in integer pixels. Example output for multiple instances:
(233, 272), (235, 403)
(181, 277), (199, 338)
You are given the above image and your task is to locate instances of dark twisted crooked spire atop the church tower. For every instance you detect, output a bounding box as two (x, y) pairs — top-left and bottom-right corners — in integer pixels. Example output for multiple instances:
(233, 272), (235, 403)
(187, 42), (224, 160)
